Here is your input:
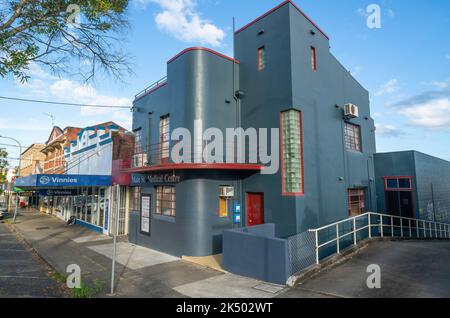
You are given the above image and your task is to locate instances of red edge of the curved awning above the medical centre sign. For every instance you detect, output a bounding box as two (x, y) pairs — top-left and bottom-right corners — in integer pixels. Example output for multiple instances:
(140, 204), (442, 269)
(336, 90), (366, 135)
(125, 163), (264, 173)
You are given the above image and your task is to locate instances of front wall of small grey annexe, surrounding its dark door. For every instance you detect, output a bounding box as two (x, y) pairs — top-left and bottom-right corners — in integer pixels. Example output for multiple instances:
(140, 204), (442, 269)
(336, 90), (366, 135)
(374, 151), (418, 215)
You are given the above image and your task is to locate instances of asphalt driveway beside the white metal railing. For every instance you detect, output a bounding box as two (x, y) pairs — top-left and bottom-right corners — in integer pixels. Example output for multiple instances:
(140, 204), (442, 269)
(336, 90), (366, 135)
(280, 240), (450, 298)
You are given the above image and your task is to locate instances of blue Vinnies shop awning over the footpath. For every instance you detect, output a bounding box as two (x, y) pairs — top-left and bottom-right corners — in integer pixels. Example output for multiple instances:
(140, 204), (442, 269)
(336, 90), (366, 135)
(14, 174), (112, 188)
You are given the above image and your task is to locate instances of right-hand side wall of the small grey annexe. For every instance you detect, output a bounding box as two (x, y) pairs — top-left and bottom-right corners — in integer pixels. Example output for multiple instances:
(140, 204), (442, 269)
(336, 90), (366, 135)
(414, 152), (450, 223)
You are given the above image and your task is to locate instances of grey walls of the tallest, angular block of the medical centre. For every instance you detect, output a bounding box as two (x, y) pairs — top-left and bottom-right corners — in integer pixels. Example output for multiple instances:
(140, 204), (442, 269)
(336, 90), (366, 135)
(236, 4), (376, 237)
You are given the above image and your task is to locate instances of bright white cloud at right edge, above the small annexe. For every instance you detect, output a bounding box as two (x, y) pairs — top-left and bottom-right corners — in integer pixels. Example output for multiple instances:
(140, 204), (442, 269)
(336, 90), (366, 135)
(398, 97), (450, 130)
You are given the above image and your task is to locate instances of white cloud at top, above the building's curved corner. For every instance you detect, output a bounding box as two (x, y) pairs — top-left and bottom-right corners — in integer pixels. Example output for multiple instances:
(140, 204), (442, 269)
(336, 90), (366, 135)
(149, 0), (225, 47)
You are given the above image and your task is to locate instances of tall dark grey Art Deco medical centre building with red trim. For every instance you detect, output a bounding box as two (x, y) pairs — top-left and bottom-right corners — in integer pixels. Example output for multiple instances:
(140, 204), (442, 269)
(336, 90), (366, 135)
(129, 1), (376, 256)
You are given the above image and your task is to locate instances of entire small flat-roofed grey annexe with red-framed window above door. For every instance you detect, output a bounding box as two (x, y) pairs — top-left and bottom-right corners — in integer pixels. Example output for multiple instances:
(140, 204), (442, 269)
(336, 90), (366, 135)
(375, 151), (450, 222)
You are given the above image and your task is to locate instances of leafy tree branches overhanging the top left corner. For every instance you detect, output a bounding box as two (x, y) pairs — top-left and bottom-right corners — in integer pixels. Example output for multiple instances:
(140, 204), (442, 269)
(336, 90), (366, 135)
(0, 0), (131, 82)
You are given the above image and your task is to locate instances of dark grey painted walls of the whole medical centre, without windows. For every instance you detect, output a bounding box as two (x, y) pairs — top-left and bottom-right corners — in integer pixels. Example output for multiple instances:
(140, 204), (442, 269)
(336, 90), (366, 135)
(130, 2), (376, 256)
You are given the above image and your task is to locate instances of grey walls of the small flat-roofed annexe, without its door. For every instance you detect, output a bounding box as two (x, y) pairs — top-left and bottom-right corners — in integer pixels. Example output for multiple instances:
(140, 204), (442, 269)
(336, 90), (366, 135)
(375, 151), (450, 222)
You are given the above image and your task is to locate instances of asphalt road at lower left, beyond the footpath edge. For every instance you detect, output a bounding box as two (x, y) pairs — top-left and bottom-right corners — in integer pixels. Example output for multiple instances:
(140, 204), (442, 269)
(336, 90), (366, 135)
(0, 223), (65, 298)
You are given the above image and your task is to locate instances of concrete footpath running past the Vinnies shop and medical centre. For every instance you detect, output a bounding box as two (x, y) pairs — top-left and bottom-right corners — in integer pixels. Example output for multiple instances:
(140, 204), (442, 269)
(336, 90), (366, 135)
(7, 212), (284, 298)
